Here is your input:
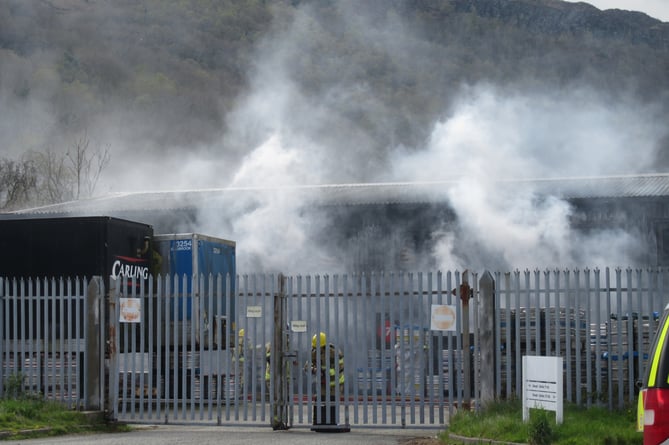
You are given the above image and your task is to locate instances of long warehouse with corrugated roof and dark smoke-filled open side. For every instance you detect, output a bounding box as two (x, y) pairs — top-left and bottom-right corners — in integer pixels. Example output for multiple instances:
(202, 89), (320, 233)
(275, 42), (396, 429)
(0, 174), (669, 273)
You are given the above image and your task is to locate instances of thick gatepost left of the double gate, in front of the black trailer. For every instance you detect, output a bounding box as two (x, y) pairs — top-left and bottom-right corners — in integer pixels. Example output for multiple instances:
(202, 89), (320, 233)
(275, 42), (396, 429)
(84, 277), (103, 410)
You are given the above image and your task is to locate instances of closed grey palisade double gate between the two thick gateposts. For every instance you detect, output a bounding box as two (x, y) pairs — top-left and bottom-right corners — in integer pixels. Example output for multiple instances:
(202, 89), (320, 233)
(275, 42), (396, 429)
(110, 274), (464, 427)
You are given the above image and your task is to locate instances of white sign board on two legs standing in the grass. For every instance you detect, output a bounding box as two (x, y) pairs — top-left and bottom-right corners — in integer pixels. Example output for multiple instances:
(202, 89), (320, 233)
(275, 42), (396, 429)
(523, 355), (563, 424)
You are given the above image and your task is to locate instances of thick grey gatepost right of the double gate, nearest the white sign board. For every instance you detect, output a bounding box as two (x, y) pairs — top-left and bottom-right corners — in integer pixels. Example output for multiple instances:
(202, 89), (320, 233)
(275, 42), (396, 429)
(478, 271), (497, 405)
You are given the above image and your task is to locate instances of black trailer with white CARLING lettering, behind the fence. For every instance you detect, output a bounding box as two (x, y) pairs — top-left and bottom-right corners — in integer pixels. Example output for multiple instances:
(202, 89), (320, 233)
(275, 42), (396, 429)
(0, 216), (153, 344)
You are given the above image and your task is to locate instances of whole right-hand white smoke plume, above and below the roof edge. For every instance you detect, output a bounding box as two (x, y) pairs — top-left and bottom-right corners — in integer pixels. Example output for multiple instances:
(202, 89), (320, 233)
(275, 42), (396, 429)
(393, 86), (659, 268)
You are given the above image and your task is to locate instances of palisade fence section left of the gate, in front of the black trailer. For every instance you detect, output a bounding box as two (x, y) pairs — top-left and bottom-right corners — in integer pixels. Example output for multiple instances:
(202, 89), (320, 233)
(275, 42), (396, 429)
(0, 278), (104, 408)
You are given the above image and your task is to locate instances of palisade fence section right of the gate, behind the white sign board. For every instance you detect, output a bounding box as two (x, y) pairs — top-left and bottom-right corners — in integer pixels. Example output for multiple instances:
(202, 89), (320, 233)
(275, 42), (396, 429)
(495, 268), (669, 408)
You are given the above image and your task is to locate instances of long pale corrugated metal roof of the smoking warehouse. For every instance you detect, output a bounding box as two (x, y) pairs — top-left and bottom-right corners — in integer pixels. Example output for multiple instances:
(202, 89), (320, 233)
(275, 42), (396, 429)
(7, 174), (669, 214)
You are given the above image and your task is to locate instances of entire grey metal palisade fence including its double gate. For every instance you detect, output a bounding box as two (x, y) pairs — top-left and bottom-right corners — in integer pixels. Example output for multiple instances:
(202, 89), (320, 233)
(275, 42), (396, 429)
(0, 268), (669, 428)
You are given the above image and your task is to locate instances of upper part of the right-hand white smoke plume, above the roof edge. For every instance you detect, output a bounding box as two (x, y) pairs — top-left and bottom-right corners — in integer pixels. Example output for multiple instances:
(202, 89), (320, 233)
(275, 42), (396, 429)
(394, 85), (660, 180)
